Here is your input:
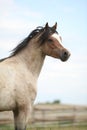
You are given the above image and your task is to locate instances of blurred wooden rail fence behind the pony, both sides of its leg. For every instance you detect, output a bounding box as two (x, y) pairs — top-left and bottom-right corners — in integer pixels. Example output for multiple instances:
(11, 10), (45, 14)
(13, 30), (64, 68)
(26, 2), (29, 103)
(0, 104), (87, 127)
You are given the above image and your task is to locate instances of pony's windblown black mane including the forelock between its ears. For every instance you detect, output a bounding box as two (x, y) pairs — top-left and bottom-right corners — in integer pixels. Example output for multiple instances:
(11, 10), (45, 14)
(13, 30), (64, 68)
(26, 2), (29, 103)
(0, 23), (57, 62)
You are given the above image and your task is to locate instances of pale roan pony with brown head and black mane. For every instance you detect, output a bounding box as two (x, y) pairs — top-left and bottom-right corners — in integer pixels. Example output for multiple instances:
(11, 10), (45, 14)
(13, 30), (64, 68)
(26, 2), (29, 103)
(0, 23), (70, 130)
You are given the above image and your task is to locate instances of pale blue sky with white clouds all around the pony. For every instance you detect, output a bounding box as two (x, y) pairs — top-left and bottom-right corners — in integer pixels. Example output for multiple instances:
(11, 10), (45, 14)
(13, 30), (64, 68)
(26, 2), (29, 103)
(0, 0), (87, 105)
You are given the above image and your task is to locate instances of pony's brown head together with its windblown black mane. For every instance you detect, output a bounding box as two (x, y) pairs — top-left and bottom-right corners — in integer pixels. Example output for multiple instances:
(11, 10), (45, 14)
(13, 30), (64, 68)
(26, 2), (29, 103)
(12, 23), (70, 61)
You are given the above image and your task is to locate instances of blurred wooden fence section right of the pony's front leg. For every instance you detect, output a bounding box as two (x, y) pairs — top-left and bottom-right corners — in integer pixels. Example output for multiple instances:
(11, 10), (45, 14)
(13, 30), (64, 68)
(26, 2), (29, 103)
(31, 105), (87, 126)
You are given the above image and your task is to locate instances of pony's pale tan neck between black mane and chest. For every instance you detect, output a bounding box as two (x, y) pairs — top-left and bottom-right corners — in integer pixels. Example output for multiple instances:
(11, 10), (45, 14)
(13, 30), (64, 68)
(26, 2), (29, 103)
(16, 40), (45, 77)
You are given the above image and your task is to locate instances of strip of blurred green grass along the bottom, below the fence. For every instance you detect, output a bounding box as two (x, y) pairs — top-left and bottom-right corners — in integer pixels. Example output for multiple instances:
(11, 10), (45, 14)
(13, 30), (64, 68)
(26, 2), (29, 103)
(0, 125), (87, 130)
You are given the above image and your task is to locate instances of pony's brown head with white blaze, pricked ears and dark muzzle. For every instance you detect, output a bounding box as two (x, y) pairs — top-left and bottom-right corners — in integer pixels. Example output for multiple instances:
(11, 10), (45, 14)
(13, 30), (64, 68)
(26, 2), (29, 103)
(39, 23), (70, 61)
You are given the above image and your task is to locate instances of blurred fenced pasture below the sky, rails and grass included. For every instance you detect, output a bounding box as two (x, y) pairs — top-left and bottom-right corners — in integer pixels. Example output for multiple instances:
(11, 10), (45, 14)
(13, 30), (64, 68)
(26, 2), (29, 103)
(0, 104), (87, 130)
